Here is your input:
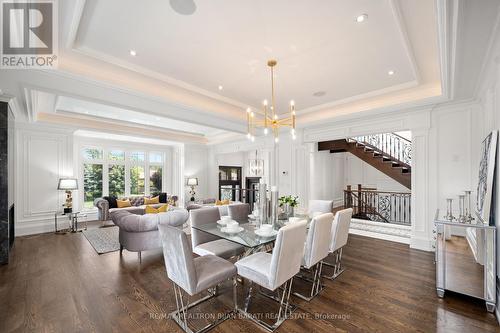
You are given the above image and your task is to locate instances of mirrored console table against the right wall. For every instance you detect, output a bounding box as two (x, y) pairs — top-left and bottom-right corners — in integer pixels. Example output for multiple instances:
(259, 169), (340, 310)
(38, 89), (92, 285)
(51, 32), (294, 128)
(434, 209), (496, 312)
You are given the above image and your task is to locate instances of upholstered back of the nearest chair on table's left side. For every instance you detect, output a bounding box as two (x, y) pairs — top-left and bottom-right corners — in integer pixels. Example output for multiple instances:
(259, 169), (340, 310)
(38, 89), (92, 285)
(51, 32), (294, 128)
(158, 224), (197, 295)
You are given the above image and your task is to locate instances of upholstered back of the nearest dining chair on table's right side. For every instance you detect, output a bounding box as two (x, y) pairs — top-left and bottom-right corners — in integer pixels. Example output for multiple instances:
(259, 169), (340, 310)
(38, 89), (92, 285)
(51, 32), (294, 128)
(269, 221), (307, 290)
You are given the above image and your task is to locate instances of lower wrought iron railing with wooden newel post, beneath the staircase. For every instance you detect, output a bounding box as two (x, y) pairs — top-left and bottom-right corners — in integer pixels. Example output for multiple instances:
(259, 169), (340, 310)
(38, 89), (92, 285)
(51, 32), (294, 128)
(344, 184), (411, 225)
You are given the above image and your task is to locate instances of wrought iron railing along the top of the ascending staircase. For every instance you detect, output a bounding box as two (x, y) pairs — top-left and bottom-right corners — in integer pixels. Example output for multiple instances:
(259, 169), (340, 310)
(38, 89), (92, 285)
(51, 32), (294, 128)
(347, 133), (411, 167)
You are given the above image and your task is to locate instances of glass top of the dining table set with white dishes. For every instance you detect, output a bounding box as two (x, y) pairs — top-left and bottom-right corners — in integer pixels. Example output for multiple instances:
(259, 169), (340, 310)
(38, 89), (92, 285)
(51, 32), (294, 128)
(192, 215), (311, 257)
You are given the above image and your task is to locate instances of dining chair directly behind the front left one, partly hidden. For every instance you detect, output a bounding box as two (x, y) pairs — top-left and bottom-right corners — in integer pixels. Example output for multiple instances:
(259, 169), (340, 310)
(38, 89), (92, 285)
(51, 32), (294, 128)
(190, 207), (244, 259)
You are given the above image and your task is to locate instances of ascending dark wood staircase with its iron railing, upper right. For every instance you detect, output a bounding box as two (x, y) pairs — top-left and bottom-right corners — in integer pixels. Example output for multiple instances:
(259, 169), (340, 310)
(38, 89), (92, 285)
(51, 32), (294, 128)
(318, 133), (411, 189)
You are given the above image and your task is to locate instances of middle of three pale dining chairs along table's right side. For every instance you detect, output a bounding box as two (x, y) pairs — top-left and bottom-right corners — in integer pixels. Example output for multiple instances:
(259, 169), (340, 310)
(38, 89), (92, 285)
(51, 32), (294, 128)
(293, 213), (333, 301)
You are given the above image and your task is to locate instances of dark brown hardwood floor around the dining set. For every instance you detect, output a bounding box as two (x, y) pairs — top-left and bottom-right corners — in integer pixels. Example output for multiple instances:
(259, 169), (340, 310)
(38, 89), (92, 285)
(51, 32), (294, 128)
(0, 230), (500, 333)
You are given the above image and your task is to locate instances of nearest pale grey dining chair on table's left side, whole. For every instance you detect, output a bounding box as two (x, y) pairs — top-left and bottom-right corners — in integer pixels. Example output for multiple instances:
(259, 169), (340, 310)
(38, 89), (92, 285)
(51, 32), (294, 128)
(158, 225), (237, 333)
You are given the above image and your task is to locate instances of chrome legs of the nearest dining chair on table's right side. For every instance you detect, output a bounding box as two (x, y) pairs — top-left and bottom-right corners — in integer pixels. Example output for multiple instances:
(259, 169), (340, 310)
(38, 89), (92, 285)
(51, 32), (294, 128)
(238, 279), (296, 332)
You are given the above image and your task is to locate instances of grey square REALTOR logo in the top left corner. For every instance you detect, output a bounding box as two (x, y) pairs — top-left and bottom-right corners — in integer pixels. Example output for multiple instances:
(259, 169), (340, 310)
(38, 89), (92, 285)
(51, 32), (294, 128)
(0, 0), (57, 69)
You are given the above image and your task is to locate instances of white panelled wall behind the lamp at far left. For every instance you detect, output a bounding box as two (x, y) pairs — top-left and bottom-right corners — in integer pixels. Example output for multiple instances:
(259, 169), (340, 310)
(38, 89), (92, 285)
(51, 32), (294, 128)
(15, 124), (73, 236)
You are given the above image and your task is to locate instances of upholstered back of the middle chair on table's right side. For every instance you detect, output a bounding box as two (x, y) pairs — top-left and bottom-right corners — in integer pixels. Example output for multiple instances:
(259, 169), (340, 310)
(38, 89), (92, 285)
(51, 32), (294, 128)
(304, 213), (333, 268)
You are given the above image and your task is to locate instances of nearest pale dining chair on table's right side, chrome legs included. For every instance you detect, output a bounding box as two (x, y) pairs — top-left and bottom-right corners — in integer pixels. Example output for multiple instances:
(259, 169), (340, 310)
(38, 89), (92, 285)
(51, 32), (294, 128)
(235, 221), (307, 331)
